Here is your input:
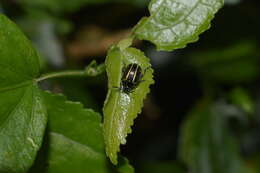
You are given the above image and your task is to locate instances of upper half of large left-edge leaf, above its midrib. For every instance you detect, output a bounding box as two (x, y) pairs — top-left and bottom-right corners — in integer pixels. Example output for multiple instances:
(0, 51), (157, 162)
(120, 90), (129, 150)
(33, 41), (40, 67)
(0, 14), (39, 90)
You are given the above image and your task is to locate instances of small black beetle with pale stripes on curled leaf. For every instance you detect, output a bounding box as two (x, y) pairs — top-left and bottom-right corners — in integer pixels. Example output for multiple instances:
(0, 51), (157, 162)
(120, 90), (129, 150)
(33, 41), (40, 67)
(120, 63), (146, 94)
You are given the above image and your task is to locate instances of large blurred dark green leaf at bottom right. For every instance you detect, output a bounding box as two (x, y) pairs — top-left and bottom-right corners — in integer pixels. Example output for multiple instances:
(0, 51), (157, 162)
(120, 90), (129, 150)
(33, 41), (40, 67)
(179, 102), (246, 173)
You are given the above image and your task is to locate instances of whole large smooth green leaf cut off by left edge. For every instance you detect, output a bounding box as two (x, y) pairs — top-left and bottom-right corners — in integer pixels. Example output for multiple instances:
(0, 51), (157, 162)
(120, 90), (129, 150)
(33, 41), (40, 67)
(0, 14), (47, 173)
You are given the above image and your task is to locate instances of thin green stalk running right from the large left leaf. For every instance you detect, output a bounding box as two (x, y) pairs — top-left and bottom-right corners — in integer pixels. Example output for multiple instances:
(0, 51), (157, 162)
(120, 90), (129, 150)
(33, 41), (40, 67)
(36, 70), (86, 82)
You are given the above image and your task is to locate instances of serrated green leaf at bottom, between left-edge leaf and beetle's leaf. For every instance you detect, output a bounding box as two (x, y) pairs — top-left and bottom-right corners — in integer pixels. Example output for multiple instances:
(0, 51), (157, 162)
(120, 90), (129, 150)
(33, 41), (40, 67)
(32, 92), (109, 173)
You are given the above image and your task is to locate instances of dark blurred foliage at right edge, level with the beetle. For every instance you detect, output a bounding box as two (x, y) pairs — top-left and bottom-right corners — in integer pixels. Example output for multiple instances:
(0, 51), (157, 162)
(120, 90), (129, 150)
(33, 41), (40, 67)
(191, 41), (260, 84)
